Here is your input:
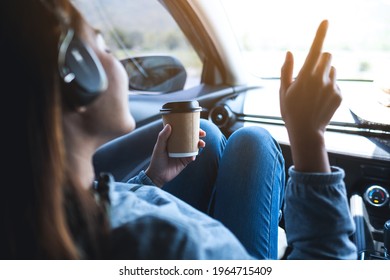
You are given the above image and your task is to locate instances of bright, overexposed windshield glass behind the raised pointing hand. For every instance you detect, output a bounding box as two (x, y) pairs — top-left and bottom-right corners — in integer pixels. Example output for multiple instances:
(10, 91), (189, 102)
(223, 0), (390, 83)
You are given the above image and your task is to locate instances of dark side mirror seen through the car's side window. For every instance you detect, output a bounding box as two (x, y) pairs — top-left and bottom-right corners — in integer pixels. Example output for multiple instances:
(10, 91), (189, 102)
(121, 56), (187, 93)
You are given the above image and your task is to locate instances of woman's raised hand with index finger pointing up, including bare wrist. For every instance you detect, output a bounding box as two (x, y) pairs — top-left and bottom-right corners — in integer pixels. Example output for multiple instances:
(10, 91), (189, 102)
(280, 20), (341, 172)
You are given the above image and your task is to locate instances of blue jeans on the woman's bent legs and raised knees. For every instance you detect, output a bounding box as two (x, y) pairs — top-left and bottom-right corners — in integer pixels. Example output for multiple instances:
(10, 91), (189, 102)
(163, 120), (285, 259)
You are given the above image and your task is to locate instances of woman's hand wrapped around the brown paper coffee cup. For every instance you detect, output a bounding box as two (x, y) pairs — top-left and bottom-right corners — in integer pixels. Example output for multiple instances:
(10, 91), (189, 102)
(145, 124), (206, 187)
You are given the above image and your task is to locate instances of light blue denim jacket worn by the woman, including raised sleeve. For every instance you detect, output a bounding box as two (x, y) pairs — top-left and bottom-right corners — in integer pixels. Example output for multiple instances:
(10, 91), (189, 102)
(103, 167), (357, 260)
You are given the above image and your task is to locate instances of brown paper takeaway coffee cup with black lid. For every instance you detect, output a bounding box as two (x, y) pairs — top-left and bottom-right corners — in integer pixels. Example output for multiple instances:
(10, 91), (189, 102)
(160, 101), (202, 157)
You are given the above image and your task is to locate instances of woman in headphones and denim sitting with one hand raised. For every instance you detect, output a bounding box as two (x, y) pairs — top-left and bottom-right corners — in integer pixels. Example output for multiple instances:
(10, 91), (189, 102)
(0, 0), (356, 259)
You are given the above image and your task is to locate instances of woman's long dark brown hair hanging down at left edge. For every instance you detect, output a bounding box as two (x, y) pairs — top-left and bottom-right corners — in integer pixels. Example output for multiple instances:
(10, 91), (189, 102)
(0, 0), (107, 259)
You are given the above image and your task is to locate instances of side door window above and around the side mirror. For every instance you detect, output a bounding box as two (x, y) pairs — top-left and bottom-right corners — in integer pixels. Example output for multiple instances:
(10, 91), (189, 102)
(72, 0), (202, 94)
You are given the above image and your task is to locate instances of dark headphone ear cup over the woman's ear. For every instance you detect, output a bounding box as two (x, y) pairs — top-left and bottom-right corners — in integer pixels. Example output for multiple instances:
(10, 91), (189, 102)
(58, 30), (108, 107)
